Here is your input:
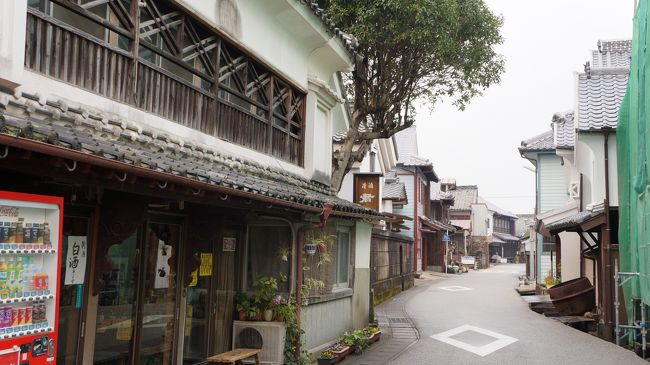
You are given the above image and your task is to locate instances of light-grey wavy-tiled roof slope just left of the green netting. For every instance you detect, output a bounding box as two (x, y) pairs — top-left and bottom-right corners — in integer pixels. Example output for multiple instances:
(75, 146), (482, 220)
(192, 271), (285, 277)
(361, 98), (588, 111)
(577, 69), (629, 131)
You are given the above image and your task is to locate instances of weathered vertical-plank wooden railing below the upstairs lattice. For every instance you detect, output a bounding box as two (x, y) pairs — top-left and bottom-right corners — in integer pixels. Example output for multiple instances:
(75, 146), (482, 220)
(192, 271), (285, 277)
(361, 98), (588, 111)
(25, 8), (304, 166)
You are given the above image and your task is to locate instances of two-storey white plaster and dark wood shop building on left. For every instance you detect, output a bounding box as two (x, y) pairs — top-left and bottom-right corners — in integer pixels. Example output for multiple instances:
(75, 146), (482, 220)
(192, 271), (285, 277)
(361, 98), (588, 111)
(0, 0), (381, 365)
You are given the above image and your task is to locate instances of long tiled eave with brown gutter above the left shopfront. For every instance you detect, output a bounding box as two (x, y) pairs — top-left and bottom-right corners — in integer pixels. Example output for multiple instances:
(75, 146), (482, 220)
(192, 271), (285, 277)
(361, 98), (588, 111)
(0, 94), (384, 219)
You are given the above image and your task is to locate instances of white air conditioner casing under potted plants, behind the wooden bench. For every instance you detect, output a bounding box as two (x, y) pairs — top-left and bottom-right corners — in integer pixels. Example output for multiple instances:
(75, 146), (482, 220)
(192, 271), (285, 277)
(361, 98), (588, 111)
(232, 321), (286, 365)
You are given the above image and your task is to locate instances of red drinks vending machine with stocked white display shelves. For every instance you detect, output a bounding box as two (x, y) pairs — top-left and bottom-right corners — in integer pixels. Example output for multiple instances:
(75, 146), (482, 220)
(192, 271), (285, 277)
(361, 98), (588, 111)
(0, 191), (63, 365)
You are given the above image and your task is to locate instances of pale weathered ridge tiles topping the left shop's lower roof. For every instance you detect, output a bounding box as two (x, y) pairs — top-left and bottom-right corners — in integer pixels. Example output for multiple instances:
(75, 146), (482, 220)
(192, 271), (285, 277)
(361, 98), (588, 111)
(0, 92), (336, 197)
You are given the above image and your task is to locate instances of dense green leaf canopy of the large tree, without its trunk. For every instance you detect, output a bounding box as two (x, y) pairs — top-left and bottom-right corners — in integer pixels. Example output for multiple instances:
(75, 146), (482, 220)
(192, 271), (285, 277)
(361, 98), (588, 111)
(320, 0), (504, 111)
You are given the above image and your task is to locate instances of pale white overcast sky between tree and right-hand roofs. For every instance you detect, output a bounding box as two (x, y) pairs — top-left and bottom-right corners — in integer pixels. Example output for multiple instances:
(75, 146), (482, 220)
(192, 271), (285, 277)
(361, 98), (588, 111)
(416, 0), (634, 213)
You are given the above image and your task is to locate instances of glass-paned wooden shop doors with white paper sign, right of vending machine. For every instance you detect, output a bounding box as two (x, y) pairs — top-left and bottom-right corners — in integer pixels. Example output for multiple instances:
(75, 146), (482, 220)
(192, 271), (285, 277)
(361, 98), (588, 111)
(93, 216), (182, 365)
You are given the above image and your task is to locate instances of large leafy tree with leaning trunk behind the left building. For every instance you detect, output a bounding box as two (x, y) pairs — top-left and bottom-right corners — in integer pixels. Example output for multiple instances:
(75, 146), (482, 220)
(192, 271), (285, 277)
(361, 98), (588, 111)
(319, 0), (504, 190)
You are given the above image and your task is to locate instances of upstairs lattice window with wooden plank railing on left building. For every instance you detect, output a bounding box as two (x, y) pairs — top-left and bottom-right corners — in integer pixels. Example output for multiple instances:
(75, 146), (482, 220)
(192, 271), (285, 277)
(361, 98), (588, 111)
(25, 0), (305, 165)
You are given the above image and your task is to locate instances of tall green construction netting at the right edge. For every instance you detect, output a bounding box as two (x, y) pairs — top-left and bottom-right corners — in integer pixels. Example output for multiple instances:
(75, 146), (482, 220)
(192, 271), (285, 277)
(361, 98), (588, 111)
(616, 0), (650, 318)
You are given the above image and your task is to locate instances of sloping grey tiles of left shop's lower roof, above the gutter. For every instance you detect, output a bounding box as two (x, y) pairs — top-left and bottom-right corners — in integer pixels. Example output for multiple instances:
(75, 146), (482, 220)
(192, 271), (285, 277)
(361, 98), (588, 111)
(0, 97), (380, 215)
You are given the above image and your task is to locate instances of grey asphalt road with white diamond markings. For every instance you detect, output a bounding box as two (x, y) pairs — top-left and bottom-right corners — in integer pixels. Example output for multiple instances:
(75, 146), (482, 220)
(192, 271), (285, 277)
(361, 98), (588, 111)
(391, 264), (647, 365)
